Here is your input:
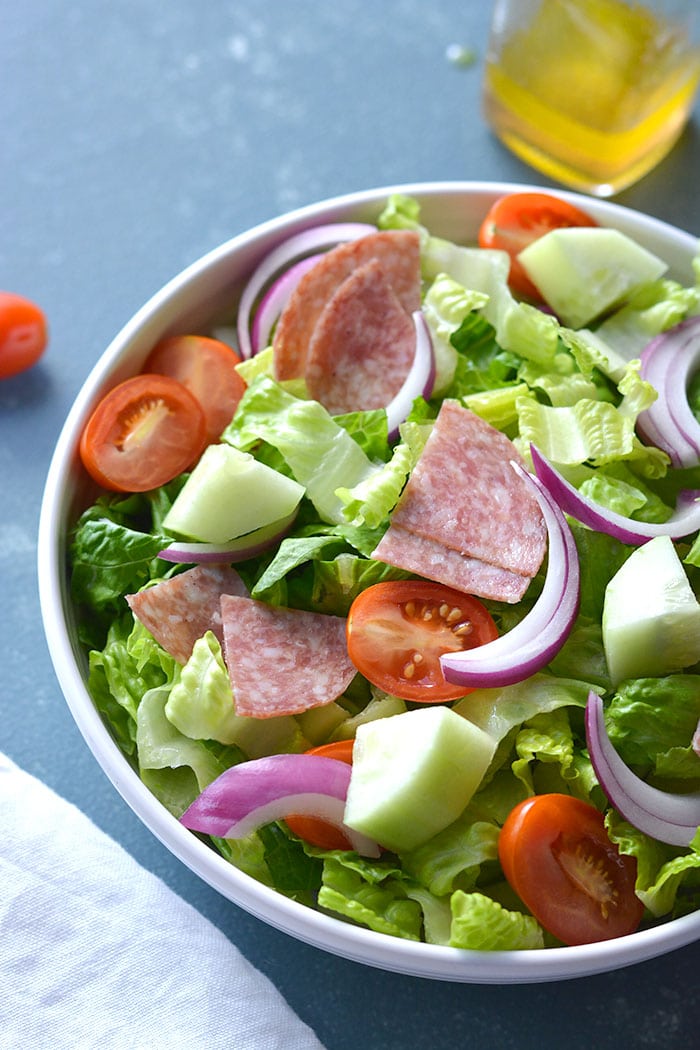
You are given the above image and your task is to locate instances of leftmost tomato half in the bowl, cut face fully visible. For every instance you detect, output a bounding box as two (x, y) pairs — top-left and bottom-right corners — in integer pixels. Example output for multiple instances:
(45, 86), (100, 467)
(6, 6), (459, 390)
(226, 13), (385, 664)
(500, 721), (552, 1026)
(80, 374), (206, 492)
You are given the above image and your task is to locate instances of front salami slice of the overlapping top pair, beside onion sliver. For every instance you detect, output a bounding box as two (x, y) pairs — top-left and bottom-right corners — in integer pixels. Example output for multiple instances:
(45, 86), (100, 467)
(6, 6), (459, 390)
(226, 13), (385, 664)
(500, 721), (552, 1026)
(305, 259), (416, 414)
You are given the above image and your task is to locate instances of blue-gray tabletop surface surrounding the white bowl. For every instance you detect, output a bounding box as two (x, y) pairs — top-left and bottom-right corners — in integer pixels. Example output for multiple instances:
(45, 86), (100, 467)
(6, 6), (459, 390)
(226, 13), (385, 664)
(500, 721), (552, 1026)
(0, 0), (700, 1050)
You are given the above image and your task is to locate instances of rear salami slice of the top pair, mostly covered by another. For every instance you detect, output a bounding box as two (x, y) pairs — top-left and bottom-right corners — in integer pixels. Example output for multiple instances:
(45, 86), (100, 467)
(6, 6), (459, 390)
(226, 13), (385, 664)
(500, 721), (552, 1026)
(273, 230), (421, 379)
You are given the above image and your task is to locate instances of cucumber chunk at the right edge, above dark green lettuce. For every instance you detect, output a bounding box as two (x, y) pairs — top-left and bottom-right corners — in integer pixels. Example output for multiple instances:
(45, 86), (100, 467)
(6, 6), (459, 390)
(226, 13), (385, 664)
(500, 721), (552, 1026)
(602, 537), (700, 685)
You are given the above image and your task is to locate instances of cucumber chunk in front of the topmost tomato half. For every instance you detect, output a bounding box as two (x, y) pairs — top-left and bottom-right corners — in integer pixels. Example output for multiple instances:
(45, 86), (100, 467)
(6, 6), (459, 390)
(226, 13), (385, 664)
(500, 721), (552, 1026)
(517, 226), (667, 329)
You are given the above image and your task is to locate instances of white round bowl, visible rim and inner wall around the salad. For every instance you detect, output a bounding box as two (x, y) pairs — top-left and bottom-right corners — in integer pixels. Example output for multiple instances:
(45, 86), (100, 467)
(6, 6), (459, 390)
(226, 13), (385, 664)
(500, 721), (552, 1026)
(39, 183), (700, 984)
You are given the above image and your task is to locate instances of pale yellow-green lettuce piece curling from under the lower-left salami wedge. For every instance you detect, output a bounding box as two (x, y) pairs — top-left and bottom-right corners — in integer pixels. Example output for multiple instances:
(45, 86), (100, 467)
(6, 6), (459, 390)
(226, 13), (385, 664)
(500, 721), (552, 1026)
(165, 631), (307, 758)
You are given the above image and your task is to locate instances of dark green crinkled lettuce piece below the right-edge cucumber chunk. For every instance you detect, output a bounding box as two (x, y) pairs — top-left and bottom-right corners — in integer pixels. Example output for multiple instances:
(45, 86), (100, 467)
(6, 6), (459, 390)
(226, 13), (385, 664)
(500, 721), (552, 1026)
(606, 674), (700, 786)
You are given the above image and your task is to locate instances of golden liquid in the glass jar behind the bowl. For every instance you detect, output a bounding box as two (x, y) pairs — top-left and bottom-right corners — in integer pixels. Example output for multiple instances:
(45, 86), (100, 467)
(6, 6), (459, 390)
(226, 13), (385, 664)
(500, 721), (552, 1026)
(484, 0), (700, 196)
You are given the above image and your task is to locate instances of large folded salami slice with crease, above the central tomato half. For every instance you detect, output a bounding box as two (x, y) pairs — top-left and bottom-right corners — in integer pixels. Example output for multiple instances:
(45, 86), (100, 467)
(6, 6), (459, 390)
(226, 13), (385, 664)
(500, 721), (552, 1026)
(373, 401), (547, 603)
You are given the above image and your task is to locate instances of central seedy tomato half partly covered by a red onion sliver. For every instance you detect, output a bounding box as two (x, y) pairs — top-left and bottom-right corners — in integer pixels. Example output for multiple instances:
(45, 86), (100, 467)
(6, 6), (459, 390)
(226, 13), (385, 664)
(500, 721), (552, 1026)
(347, 580), (497, 704)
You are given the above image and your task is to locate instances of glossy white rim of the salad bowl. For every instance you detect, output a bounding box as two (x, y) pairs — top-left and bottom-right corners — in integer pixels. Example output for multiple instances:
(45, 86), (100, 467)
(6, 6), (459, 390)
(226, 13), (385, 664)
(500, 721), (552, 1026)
(37, 181), (700, 984)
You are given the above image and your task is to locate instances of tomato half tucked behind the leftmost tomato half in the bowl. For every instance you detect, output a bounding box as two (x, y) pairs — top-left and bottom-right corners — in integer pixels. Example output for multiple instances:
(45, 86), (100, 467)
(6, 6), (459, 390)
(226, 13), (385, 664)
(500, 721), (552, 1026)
(144, 335), (246, 444)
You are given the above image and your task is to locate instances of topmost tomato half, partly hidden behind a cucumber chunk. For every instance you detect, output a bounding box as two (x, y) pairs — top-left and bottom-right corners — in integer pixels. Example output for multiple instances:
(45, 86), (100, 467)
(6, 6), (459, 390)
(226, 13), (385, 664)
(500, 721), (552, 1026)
(479, 193), (598, 301)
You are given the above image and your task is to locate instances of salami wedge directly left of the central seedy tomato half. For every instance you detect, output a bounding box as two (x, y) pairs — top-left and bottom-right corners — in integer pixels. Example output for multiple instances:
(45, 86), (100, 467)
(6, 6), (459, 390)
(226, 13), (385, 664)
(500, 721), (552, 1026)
(221, 594), (357, 718)
